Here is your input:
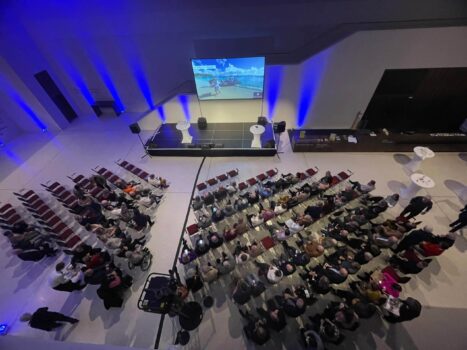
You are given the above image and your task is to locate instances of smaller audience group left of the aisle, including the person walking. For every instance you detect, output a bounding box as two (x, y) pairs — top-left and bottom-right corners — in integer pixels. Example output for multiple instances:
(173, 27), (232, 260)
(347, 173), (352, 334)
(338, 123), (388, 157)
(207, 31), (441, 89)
(0, 170), (168, 331)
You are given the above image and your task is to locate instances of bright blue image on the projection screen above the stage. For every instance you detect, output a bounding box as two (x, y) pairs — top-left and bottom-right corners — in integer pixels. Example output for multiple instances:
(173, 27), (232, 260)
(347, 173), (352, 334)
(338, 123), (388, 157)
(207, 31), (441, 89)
(191, 57), (264, 100)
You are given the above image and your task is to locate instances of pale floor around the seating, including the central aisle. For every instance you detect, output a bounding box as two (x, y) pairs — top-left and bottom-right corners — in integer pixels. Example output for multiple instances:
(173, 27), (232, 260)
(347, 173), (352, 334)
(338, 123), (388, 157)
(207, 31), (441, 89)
(0, 118), (467, 349)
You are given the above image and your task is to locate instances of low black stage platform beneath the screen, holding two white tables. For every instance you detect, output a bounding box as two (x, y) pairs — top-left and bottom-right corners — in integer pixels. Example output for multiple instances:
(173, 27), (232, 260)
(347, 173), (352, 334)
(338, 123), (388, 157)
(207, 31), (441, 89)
(146, 123), (276, 157)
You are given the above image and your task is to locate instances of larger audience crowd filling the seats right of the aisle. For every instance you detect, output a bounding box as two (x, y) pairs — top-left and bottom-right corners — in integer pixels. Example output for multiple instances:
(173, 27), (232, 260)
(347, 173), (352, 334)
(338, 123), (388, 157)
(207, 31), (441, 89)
(179, 172), (460, 349)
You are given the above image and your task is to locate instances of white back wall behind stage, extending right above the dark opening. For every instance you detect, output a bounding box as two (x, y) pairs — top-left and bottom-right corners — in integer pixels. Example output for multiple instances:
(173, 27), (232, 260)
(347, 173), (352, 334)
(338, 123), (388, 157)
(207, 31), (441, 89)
(141, 27), (467, 130)
